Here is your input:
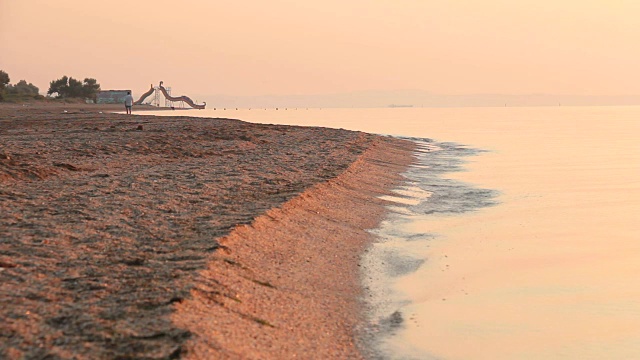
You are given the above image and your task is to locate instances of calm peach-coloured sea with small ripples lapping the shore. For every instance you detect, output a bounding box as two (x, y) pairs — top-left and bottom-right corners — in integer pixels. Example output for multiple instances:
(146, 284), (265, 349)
(141, 107), (640, 359)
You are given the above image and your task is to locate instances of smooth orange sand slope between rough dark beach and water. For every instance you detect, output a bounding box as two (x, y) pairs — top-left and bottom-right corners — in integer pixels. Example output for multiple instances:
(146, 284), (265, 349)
(172, 137), (415, 359)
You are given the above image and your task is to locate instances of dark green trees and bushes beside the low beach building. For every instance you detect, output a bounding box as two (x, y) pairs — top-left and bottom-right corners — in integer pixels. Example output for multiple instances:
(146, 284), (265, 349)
(0, 70), (100, 102)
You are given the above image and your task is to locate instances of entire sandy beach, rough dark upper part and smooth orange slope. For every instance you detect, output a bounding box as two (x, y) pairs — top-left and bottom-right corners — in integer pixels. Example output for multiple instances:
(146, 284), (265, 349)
(0, 105), (413, 359)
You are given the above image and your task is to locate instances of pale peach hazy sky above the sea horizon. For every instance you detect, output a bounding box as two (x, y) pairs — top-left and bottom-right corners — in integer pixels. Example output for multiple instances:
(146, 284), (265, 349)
(0, 0), (640, 102)
